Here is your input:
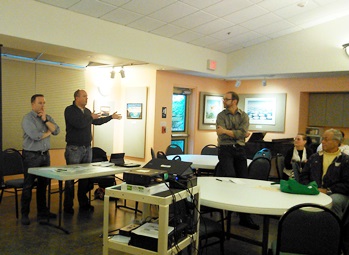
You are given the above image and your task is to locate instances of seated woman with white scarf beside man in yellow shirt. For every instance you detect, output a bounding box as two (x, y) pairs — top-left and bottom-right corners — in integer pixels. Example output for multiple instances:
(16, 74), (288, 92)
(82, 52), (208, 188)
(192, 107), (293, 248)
(284, 133), (313, 179)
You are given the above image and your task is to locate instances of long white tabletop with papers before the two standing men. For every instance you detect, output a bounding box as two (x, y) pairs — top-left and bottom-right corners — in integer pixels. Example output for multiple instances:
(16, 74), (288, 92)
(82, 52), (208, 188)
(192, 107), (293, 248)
(28, 163), (138, 181)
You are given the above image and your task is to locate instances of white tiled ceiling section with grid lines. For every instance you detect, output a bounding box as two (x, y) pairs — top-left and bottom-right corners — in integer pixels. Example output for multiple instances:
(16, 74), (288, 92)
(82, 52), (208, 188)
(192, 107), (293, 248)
(36, 0), (349, 53)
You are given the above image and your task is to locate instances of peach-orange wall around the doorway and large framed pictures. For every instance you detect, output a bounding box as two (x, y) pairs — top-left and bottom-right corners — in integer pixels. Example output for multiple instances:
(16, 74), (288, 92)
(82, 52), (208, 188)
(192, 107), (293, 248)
(153, 71), (349, 154)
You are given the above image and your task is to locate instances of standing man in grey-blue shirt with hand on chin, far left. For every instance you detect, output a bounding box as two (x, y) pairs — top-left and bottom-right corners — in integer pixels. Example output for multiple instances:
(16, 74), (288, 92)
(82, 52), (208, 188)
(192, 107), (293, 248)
(21, 94), (60, 225)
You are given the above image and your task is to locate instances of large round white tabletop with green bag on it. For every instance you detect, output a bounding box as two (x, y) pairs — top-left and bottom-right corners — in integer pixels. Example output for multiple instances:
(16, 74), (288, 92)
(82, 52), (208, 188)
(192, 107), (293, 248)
(198, 177), (332, 215)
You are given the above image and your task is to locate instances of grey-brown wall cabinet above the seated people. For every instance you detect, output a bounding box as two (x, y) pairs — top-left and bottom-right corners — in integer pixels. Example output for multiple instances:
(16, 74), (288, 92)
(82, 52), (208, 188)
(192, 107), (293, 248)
(308, 93), (349, 127)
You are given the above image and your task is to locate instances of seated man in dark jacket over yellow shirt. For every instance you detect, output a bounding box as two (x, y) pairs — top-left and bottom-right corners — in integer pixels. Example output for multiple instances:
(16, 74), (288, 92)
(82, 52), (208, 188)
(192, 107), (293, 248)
(299, 129), (349, 219)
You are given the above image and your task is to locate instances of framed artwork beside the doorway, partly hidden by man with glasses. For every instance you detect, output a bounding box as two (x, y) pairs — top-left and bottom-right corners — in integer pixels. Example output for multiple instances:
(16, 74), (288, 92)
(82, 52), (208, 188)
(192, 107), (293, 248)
(199, 92), (224, 130)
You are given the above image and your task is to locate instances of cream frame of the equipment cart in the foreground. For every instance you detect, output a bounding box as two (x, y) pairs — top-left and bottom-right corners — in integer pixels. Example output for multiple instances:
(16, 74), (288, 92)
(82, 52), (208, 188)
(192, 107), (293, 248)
(103, 186), (200, 255)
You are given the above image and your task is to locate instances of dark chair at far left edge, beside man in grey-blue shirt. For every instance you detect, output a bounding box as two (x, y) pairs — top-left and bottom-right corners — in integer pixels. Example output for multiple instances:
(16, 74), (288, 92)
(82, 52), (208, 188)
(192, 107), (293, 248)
(0, 148), (24, 219)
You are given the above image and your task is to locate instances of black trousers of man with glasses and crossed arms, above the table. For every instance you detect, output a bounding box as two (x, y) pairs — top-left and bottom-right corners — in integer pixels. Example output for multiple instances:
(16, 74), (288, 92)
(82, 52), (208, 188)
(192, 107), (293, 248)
(216, 145), (248, 178)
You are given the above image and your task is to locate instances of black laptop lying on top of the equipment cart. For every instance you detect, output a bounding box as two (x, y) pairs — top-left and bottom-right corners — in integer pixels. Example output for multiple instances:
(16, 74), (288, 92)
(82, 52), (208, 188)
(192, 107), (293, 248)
(143, 158), (193, 176)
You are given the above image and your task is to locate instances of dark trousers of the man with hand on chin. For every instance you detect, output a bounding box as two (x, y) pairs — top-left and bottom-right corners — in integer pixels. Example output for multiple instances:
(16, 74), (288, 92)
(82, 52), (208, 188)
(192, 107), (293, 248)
(21, 150), (50, 215)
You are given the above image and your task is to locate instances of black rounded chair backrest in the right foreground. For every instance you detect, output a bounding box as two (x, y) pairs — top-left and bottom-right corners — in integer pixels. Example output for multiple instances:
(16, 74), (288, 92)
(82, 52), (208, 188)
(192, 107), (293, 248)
(276, 203), (341, 255)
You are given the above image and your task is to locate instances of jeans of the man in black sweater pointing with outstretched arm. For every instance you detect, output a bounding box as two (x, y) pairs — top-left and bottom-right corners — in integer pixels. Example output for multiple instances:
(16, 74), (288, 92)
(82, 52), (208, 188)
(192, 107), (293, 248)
(64, 145), (92, 209)
